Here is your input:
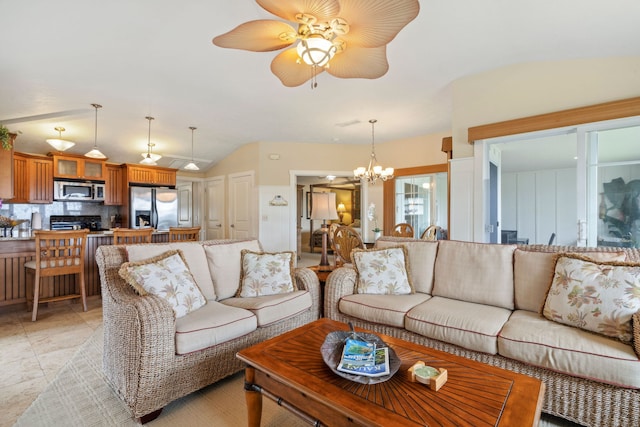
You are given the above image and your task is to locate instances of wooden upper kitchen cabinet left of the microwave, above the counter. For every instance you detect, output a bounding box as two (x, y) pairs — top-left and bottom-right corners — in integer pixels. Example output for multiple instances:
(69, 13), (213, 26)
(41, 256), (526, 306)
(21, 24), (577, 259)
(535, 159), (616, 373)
(10, 153), (53, 203)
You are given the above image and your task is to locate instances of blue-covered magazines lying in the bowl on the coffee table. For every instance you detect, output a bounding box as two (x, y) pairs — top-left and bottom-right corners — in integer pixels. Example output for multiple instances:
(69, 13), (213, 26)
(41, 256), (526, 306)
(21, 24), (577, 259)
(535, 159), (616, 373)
(338, 339), (389, 377)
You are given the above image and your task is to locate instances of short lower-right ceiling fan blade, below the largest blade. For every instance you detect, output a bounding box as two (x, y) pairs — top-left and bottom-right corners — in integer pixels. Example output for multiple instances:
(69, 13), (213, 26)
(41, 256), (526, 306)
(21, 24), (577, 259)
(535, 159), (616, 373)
(327, 45), (389, 79)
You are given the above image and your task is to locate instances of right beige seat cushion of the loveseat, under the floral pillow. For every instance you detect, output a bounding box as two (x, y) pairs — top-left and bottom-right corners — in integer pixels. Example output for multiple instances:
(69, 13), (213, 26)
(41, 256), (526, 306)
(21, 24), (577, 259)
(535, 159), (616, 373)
(221, 291), (312, 326)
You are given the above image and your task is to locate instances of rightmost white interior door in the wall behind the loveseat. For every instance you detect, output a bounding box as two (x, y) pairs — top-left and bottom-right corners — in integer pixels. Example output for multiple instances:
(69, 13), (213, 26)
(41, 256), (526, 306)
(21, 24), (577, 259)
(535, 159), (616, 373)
(229, 172), (256, 239)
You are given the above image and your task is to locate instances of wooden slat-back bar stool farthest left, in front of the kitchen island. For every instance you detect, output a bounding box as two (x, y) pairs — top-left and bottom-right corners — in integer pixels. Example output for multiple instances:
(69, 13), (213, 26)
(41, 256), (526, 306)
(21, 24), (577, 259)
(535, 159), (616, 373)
(24, 229), (89, 322)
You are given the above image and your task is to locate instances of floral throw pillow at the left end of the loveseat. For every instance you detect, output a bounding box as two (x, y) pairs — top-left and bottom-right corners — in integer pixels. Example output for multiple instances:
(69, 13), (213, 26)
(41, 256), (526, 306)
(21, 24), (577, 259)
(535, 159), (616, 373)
(118, 249), (207, 318)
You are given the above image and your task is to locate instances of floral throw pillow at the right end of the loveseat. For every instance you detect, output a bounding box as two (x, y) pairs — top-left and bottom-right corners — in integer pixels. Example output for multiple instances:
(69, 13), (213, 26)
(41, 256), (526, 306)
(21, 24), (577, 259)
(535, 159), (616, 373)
(236, 249), (296, 298)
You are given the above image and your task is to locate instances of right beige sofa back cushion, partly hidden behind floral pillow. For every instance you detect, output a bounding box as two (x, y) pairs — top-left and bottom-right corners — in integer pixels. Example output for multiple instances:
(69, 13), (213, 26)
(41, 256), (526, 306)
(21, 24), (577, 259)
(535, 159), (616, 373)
(513, 249), (626, 313)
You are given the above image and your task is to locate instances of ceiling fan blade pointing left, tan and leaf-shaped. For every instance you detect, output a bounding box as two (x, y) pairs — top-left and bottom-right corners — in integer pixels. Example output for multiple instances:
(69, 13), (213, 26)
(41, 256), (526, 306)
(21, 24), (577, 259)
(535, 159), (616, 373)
(213, 19), (296, 52)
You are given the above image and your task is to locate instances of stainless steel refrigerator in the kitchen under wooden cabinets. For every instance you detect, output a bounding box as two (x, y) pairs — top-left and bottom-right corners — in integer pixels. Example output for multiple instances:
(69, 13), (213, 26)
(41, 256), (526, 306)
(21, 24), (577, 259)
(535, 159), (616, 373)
(129, 186), (178, 230)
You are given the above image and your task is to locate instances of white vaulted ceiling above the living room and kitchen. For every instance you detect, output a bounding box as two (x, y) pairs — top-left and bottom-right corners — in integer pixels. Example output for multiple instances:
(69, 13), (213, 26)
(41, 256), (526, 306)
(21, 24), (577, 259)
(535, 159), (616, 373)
(0, 0), (640, 170)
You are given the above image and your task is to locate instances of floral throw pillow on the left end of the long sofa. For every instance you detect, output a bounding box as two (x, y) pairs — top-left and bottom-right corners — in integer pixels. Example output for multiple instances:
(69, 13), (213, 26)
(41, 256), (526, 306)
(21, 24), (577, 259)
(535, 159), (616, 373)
(351, 246), (414, 295)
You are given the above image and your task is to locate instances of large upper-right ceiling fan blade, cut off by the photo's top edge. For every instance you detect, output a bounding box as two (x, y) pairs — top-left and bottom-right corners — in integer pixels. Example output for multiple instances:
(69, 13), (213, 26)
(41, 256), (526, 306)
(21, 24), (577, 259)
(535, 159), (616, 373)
(340, 0), (420, 48)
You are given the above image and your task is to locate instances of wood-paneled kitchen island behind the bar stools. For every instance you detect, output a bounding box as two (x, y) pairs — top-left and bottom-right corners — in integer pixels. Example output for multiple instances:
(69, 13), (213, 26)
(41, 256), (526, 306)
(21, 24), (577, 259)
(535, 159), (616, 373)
(0, 231), (169, 309)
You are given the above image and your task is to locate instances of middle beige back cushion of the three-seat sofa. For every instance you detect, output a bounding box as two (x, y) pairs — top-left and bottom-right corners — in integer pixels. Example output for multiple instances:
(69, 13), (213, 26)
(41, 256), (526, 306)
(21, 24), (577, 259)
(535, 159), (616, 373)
(433, 240), (516, 310)
